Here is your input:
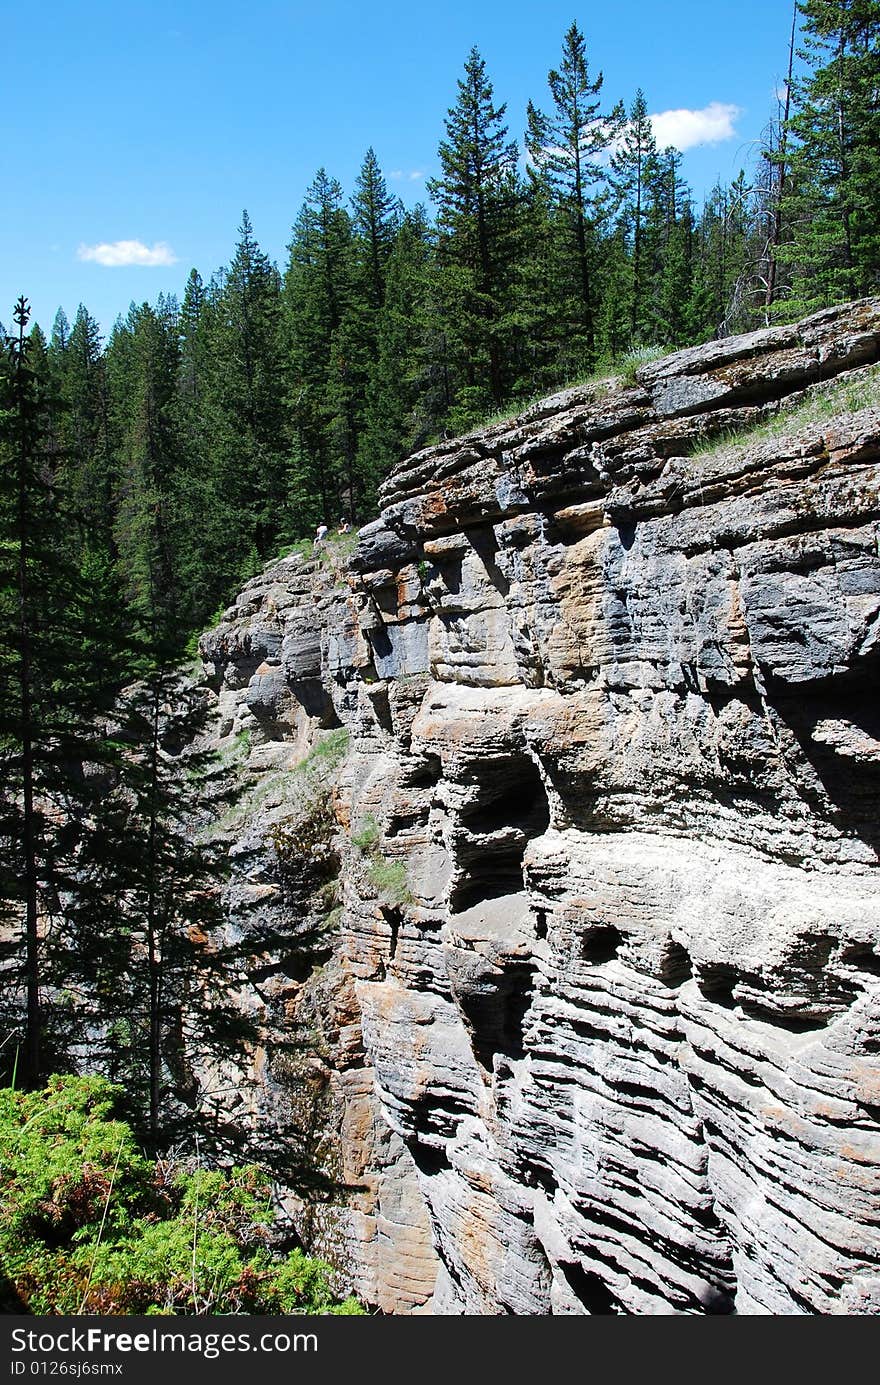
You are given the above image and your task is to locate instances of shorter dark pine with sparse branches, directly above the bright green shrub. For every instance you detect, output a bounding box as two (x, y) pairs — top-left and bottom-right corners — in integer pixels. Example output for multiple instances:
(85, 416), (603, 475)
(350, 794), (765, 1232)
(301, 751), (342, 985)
(94, 670), (236, 1150)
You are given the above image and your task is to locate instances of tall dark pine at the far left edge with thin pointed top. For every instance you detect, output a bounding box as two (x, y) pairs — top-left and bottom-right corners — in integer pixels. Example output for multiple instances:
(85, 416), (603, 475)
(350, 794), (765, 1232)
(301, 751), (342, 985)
(0, 299), (133, 1084)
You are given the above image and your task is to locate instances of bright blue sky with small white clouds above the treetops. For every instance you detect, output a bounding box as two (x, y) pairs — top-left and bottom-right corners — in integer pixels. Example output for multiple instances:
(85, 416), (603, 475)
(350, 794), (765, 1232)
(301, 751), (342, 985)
(0, 0), (791, 331)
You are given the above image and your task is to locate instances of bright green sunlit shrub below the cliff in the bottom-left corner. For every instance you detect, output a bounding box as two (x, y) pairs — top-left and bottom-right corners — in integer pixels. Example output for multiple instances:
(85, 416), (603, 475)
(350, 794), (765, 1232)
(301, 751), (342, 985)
(0, 1078), (363, 1314)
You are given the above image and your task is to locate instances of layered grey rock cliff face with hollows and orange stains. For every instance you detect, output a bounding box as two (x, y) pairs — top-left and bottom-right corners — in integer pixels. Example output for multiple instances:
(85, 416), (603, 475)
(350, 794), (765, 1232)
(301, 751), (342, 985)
(202, 301), (880, 1314)
